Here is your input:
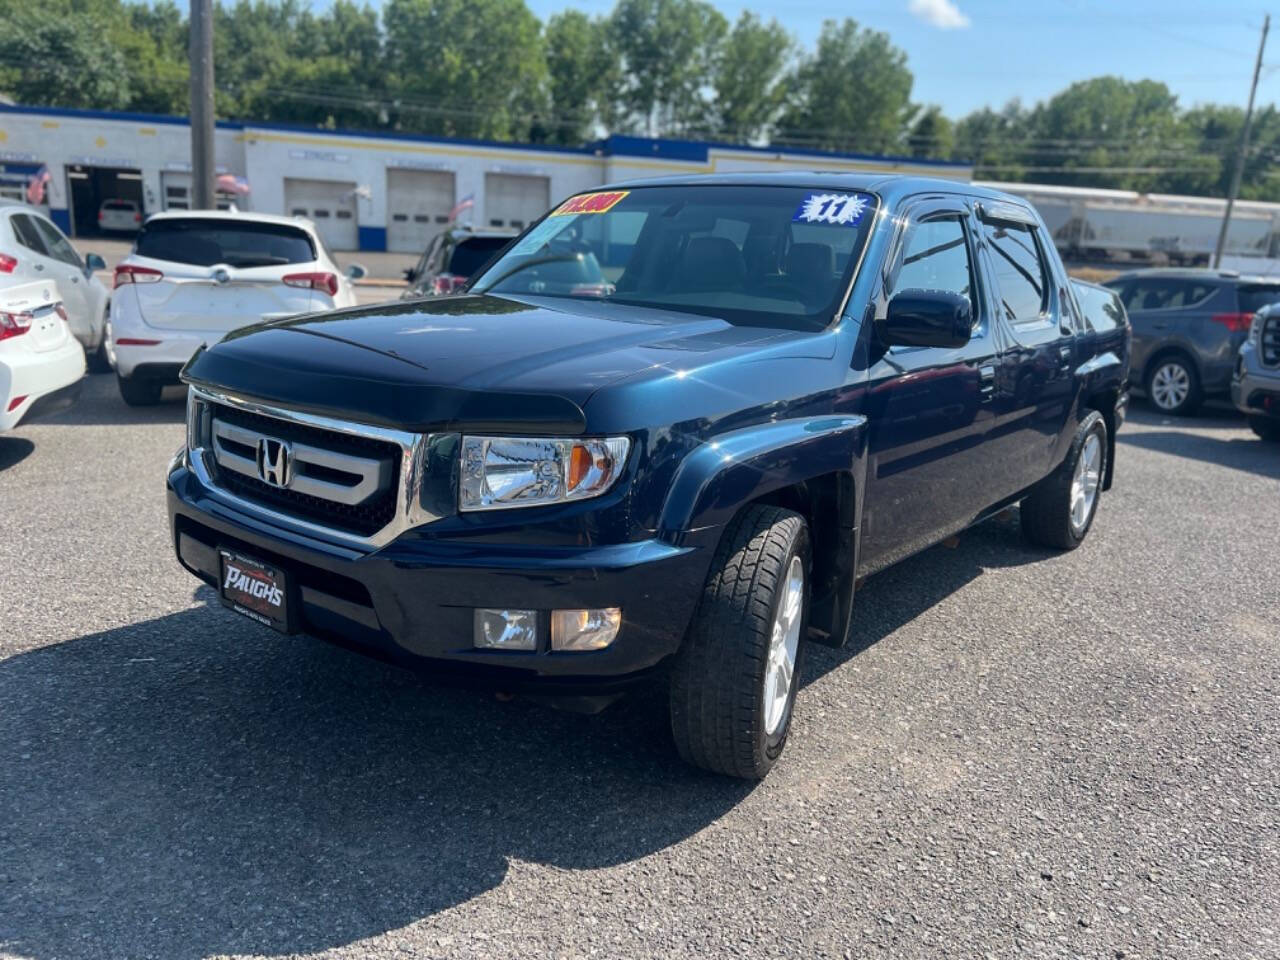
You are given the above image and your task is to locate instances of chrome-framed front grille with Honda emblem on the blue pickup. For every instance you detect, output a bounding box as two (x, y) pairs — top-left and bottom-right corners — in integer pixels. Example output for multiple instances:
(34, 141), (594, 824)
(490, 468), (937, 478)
(188, 388), (445, 547)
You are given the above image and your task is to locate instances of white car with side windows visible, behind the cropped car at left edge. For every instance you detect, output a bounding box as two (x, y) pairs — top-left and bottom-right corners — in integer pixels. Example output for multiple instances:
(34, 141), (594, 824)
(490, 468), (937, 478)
(0, 200), (111, 371)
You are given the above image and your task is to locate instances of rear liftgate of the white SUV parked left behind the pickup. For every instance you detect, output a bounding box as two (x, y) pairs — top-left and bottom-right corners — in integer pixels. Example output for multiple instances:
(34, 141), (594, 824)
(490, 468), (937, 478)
(115, 216), (320, 333)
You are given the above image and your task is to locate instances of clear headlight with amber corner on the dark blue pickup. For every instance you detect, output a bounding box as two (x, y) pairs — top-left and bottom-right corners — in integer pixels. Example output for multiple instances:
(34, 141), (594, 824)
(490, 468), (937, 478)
(458, 436), (631, 509)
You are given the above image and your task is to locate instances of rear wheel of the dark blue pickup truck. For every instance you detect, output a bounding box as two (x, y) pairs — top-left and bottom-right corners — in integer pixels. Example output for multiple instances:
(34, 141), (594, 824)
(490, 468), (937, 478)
(1019, 410), (1107, 550)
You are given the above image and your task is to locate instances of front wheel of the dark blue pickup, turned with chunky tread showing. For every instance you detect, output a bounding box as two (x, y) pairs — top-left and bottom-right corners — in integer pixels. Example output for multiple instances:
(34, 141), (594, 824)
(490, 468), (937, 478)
(669, 506), (810, 780)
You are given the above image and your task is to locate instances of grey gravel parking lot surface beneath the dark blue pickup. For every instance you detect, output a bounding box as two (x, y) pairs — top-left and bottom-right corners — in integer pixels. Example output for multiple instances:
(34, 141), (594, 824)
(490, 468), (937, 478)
(0, 376), (1280, 960)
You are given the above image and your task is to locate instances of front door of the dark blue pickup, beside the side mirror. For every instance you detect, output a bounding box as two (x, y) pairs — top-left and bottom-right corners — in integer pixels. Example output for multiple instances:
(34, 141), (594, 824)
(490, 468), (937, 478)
(861, 198), (1000, 572)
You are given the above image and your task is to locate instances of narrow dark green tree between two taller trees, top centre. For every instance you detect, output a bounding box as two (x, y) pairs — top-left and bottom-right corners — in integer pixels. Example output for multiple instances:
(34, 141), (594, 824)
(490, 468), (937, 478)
(545, 10), (618, 143)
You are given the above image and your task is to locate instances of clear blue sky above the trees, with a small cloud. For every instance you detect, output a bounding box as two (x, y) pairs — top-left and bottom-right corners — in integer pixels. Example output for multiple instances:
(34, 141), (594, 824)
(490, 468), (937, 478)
(524, 0), (1280, 116)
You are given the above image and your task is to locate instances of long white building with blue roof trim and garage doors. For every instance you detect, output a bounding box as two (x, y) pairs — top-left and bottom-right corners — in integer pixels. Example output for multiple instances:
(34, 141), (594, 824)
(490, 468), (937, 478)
(0, 104), (973, 252)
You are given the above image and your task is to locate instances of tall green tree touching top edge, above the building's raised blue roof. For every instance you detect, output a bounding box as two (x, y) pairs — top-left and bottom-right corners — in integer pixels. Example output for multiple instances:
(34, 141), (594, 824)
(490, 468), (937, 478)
(607, 0), (727, 136)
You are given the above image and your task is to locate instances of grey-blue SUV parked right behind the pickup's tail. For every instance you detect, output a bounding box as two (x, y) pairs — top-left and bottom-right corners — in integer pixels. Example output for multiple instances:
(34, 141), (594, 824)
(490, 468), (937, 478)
(1105, 269), (1280, 416)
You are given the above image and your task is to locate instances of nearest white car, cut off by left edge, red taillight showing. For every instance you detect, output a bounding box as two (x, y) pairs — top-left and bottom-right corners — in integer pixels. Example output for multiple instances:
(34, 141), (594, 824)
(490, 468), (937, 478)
(0, 280), (84, 433)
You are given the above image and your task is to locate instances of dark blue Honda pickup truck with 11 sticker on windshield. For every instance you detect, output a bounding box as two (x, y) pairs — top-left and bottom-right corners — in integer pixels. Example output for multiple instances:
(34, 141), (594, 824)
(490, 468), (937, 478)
(168, 173), (1129, 778)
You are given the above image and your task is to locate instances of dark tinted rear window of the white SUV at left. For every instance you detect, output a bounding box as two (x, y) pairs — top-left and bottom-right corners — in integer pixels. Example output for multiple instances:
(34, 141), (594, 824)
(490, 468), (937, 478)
(134, 218), (316, 266)
